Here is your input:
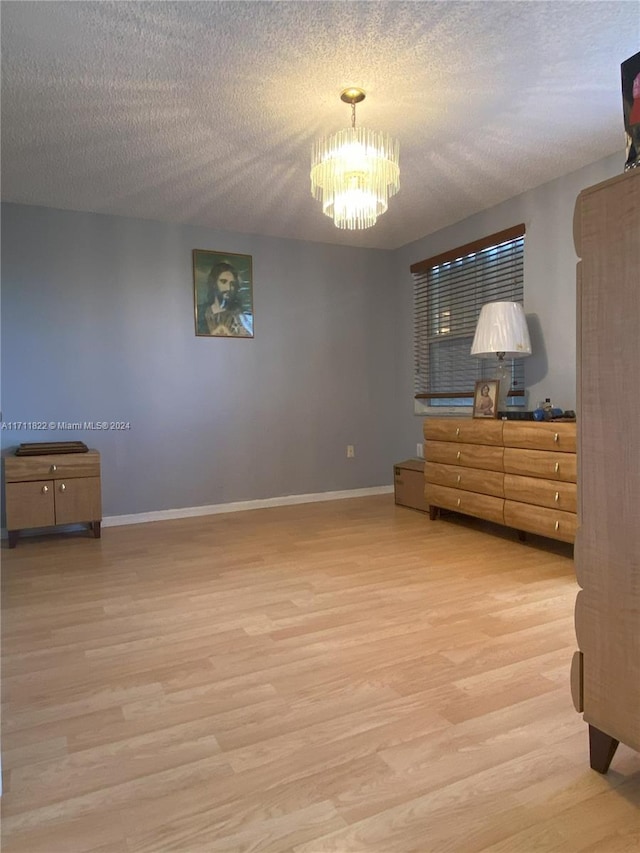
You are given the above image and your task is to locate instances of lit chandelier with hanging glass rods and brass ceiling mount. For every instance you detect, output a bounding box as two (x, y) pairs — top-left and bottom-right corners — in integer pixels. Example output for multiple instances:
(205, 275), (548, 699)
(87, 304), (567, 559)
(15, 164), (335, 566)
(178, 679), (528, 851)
(311, 87), (400, 230)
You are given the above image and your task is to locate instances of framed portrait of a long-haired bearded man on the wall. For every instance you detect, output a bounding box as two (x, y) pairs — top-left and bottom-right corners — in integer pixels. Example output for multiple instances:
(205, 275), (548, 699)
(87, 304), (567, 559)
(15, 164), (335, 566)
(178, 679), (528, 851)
(193, 249), (253, 338)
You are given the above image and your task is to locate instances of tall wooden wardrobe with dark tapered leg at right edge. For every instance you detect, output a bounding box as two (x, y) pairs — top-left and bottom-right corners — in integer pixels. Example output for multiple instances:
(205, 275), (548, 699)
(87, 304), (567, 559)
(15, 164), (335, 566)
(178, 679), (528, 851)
(571, 169), (640, 773)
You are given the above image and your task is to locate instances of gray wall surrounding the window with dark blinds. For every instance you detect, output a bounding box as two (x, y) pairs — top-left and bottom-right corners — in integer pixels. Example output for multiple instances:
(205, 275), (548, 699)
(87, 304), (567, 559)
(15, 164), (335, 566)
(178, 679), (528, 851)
(396, 152), (625, 460)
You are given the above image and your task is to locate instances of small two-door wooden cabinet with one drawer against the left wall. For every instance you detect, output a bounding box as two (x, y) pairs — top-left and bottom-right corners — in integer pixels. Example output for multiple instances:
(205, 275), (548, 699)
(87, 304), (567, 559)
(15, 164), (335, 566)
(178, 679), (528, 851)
(4, 450), (102, 548)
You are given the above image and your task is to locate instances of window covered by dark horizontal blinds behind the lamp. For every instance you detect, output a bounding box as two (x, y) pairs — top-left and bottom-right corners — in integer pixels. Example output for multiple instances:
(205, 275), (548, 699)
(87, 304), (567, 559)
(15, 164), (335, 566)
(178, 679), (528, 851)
(411, 225), (525, 406)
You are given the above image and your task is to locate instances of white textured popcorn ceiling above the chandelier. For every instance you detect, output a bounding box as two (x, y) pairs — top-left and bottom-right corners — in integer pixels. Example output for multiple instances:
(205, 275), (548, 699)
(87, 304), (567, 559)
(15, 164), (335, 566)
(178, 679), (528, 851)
(2, 0), (640, 248)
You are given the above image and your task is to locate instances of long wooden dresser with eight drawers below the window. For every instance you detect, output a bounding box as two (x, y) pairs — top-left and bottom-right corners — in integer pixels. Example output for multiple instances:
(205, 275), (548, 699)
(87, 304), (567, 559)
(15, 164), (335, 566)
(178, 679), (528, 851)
(424, 418), (576, 542)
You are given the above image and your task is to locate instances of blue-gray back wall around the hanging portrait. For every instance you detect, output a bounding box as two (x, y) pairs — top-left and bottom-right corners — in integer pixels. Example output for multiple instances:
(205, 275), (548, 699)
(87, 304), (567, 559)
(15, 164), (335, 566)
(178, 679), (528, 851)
(2, 204), (402, 516)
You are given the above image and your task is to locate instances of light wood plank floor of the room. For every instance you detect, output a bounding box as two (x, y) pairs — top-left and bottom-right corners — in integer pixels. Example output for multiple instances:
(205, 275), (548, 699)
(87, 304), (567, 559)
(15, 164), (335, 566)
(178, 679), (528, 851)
(2, 495), (640, 853)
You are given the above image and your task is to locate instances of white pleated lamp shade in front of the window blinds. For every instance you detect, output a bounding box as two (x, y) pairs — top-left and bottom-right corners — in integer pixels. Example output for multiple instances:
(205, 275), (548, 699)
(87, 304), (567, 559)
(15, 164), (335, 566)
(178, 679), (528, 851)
(471, 302), (531, 358)
